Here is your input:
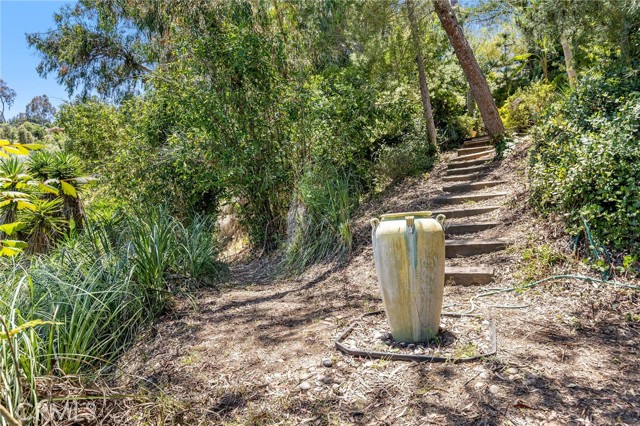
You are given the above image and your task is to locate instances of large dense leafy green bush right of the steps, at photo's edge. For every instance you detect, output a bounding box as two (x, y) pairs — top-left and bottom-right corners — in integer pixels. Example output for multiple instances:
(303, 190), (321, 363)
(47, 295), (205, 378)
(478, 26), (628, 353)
(530, 69), (640, 254)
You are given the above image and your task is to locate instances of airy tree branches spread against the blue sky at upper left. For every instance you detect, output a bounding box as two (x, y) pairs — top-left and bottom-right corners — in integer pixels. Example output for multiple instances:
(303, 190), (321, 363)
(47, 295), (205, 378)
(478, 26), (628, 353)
(27, 0), (180, 99)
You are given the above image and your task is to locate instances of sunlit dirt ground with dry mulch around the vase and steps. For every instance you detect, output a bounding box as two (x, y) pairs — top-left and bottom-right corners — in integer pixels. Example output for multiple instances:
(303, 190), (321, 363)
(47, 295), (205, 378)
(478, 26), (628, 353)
(117, 138), (640, 425)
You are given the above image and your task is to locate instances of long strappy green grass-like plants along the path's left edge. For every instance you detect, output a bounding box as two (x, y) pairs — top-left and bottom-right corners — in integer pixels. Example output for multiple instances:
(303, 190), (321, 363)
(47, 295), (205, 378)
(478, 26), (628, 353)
(0, 210), (226, 424)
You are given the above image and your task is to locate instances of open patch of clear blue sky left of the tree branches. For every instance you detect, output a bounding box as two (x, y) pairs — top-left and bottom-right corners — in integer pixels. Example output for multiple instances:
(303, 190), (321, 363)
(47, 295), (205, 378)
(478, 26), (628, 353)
(0, 0), (75, 118)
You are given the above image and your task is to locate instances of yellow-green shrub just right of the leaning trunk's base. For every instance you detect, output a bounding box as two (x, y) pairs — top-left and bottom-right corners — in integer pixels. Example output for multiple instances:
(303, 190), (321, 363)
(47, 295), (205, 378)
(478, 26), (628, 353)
(499, 81), (556, 131)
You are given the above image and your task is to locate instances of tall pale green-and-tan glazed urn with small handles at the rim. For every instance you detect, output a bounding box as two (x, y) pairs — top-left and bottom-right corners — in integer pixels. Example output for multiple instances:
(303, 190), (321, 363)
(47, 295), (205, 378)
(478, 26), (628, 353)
(371, 212), (445, 342)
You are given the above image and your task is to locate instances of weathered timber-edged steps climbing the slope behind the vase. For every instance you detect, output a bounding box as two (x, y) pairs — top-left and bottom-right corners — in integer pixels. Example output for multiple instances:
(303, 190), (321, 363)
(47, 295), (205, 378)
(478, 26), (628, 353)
(438, 136), (508, 285)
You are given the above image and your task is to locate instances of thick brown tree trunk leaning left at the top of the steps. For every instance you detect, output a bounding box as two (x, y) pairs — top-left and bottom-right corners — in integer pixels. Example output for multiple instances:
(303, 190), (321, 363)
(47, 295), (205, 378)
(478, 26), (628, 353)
(433, 0), (504, 138)
